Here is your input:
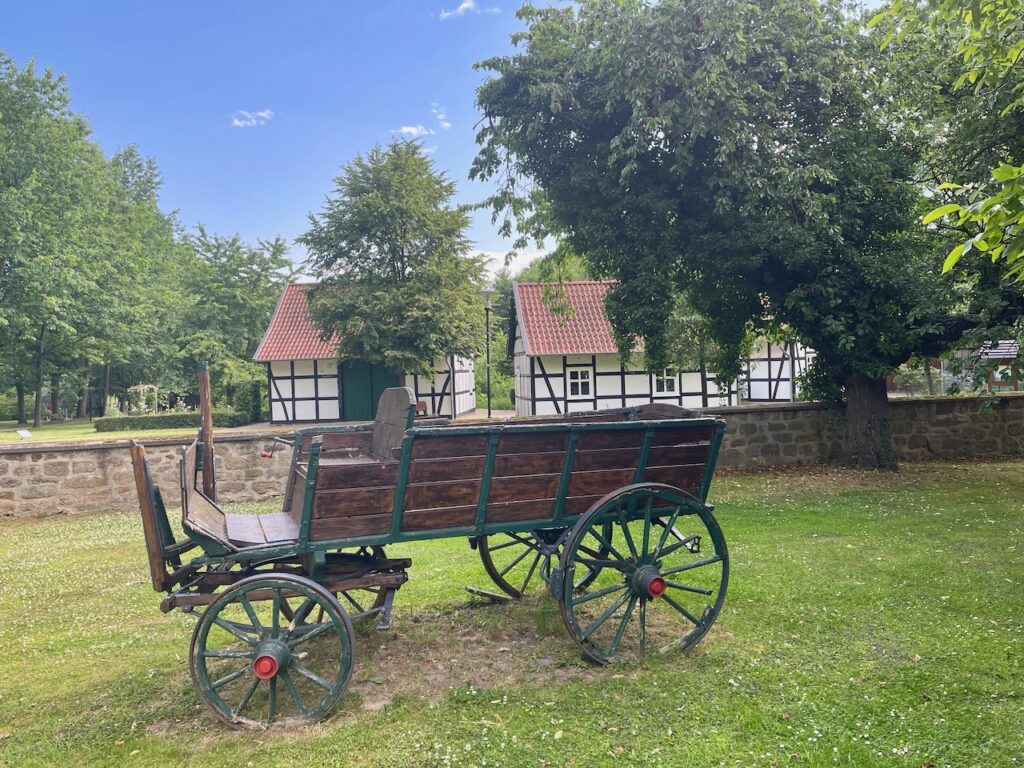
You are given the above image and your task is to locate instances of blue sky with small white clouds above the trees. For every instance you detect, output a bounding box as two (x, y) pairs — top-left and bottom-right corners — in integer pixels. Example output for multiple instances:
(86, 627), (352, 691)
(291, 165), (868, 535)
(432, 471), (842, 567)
(0, 0), (544, 276)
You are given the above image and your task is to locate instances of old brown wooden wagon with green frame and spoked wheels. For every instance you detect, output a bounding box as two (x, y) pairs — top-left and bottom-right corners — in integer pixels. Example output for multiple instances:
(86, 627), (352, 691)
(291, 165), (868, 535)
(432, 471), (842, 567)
(131, 388), (729, 726)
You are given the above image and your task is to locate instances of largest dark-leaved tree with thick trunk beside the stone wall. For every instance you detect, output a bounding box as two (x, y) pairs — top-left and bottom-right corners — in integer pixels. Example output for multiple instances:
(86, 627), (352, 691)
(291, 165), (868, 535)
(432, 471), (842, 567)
(473, 0), (1015, 468)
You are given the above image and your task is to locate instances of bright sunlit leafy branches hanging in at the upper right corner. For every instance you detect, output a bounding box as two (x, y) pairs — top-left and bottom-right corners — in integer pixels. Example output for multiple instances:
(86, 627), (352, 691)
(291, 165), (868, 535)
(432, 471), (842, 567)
(871, 0), (1024, 283)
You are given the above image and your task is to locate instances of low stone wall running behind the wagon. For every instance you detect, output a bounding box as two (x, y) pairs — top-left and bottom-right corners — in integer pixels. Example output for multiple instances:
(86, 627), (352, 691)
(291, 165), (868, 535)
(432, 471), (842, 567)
(0, 395), (1024, 517)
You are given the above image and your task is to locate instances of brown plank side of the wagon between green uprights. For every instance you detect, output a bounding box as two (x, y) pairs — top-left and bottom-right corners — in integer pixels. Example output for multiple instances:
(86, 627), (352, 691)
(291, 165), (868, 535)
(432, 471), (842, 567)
(310, 418), (716, 540)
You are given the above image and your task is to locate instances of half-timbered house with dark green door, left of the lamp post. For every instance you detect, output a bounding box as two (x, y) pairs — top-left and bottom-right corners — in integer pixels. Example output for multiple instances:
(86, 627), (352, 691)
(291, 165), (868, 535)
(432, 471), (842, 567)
(253, 284), (476, 424)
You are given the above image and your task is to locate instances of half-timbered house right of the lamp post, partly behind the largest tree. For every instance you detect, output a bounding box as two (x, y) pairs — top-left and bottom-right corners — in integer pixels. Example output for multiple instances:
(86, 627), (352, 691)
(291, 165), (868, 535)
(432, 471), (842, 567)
(508, 281), (811, 416)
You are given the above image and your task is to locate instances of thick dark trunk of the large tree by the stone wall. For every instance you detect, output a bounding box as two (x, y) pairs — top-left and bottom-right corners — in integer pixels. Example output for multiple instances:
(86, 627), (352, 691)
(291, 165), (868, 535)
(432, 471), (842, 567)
(843, 373), (899, 471)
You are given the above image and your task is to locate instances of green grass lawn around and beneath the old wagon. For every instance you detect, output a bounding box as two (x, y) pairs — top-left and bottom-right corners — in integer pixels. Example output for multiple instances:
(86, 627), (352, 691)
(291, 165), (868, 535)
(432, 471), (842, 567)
(0, 461), (1024, 768)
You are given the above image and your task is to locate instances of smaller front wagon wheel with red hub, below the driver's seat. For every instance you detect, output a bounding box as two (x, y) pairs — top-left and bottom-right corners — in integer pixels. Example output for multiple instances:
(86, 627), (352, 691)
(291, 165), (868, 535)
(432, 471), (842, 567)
(189, 573), (355, 728)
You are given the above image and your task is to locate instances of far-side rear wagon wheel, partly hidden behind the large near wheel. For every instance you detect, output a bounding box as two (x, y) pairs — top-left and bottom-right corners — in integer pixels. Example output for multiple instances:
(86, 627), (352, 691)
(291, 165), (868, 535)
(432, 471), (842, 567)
(477, 528), (598, 599)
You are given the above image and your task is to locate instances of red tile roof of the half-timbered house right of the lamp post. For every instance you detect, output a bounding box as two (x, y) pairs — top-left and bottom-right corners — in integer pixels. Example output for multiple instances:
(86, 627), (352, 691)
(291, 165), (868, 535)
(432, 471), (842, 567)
(515, 281), (617, 355)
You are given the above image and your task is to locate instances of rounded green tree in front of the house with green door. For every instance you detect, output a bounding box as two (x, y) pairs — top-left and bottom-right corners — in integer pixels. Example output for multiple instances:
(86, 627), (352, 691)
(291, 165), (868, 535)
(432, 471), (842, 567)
(299, 141), (483, 374)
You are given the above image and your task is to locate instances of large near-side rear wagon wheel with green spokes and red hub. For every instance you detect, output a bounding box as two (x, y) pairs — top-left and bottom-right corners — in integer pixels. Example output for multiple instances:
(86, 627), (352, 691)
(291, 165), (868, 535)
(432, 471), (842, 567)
(560, 483), (729, 664)
